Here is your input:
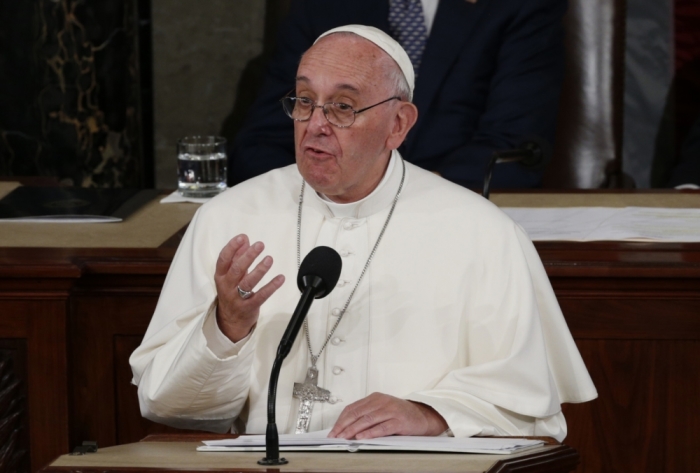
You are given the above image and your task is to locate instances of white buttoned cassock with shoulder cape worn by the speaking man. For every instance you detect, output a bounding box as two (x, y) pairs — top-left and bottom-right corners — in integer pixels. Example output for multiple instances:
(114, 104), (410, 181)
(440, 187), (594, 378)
(130, 152), (597, 440)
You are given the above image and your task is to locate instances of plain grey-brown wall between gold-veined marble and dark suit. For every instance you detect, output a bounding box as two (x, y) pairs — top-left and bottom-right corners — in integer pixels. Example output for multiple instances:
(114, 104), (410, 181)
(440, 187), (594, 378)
(153, 0), (265, 189)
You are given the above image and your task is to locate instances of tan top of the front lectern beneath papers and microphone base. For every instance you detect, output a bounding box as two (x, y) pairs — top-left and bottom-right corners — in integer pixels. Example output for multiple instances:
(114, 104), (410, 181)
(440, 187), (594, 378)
(41, 441), (579, 473)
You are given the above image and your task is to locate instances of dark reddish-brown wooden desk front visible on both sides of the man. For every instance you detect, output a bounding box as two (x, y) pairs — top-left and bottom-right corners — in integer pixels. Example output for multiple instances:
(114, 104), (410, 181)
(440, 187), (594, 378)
(0, 192), (700, 472)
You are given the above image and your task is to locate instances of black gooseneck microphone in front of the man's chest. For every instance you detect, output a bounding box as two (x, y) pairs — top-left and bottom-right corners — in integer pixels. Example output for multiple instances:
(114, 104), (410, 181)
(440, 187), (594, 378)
(258, 246), (343, 465)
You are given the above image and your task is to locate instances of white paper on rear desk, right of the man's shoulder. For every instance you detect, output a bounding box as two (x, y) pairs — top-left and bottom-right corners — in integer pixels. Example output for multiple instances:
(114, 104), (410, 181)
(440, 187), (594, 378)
(502, 207), (700, 242)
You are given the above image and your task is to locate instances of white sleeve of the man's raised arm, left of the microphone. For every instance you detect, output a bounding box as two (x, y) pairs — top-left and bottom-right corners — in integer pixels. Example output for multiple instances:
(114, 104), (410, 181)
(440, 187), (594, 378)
(129, 209), (256, 432)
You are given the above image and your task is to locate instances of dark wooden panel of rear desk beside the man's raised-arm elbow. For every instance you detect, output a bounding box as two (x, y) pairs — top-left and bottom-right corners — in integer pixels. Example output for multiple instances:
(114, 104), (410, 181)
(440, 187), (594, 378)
(71, 290), (190, 452)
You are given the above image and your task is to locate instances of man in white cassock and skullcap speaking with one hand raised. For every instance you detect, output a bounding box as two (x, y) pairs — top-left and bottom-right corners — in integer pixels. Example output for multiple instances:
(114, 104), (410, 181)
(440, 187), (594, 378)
(130, 25), (597, 440)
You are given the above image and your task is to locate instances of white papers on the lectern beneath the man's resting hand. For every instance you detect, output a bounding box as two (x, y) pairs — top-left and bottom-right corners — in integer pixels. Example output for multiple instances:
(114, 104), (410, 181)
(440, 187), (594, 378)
(197, 430), (544, 455)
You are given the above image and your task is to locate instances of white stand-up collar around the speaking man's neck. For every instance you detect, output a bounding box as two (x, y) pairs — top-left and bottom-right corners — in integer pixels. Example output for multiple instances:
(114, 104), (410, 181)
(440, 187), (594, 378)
(304, 150), (405, 218)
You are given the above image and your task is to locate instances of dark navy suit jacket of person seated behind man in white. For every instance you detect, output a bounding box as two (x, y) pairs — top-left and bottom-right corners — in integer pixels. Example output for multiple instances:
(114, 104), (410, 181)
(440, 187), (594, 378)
(229, 0), (566, 188)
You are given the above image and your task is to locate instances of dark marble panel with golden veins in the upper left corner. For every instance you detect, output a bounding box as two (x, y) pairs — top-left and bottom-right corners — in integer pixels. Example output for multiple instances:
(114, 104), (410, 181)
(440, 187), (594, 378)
(0, 0), (152, 187)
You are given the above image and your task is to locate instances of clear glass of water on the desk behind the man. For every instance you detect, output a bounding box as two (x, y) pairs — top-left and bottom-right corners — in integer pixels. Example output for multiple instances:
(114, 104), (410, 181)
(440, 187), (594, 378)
(177, 136), (226, 197)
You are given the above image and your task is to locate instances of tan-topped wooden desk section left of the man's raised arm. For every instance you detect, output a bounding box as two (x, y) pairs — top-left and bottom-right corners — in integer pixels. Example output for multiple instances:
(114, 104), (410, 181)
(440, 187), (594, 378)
(0, 182), (199, 471)
